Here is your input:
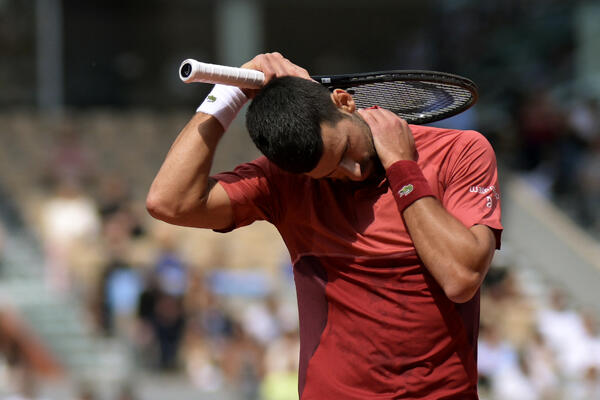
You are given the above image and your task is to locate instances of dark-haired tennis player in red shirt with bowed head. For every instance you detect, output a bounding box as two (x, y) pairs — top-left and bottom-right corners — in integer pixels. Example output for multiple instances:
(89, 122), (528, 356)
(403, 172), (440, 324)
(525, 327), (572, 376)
(147, 53), (502, 400)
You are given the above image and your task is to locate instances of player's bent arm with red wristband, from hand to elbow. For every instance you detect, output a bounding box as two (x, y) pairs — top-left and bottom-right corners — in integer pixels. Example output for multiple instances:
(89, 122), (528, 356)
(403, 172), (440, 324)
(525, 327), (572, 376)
(360, 109), (496, 303)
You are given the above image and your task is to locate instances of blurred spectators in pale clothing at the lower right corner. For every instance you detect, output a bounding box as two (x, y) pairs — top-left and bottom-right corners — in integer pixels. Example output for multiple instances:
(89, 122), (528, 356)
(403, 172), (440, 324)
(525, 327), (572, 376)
(478, 267), (600, 400)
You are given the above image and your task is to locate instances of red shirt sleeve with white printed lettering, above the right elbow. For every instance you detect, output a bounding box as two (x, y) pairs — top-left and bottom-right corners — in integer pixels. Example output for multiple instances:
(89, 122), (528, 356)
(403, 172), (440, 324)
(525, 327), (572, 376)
(442, 131), (503, 249)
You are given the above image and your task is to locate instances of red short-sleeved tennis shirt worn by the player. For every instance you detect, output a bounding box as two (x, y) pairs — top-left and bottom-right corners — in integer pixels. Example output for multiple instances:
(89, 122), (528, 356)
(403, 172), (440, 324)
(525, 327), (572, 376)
(215, 126), (502, 400)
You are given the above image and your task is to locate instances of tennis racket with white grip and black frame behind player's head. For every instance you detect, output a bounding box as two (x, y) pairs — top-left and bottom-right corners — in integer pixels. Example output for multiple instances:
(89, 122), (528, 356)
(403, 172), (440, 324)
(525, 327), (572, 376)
(179, 59), (478, 124)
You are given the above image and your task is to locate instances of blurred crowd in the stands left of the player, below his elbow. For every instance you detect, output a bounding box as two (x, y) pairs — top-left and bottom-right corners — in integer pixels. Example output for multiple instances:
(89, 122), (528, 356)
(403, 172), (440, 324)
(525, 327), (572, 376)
(0, 113), (299, 400)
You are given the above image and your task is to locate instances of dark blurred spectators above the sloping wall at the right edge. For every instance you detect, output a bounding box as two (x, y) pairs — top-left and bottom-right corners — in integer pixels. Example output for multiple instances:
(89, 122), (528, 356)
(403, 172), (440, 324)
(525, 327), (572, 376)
(504, 91), (600, 238)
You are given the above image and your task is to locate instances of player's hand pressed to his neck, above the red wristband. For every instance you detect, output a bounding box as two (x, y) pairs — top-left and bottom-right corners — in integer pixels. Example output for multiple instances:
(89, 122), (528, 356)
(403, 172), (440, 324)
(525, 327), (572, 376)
(358, 107), (417, 170)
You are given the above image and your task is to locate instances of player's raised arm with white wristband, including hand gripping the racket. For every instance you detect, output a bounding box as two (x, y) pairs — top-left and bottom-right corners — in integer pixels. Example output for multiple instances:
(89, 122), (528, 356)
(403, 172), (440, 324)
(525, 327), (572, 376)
(146, 53), (310, 229)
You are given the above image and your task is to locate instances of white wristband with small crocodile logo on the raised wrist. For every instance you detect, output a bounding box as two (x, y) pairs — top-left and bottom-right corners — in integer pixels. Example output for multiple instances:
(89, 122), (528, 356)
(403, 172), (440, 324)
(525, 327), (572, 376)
(196, 84), (248, 130)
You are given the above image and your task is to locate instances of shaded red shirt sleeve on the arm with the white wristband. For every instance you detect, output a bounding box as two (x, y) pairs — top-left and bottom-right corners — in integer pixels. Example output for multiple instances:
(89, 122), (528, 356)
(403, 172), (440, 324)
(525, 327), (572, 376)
(213, 157), (279, 232)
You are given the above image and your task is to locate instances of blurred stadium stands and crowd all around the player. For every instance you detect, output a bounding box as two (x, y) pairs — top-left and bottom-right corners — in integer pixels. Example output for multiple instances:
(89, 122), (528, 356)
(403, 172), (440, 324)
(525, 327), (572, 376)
(0, 0), (600, 400)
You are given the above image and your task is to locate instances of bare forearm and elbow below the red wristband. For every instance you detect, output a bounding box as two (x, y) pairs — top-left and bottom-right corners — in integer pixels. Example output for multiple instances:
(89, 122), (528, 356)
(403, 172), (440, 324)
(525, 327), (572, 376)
(403, 197), (495, 302)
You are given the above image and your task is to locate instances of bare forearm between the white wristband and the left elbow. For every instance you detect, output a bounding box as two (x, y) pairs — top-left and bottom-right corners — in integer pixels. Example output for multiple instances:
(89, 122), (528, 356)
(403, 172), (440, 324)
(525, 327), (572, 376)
(146, 112), (224, 219)
